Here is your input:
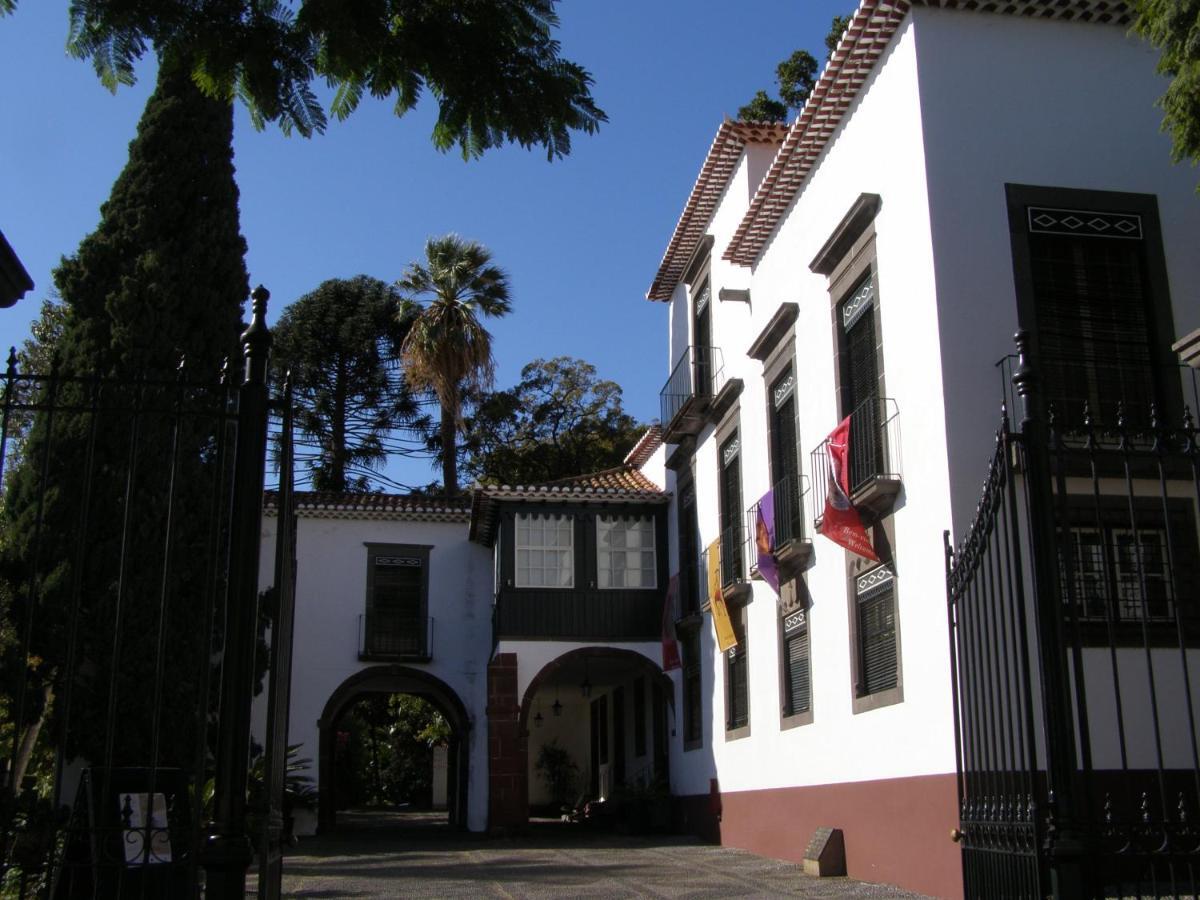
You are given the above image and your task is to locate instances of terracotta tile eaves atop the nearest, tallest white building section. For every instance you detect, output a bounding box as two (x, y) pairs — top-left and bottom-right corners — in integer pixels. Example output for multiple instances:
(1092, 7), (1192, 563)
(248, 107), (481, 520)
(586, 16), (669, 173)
(720, 0), (1130, 267)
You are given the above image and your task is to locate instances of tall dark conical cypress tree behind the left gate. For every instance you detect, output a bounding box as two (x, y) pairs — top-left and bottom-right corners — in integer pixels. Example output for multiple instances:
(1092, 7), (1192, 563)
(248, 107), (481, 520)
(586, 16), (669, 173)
(0, 56), (248, 799)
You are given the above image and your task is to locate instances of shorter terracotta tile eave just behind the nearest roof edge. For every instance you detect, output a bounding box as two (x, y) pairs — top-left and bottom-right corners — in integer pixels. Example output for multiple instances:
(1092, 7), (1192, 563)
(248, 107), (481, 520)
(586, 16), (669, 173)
(646, 119), (787, 300)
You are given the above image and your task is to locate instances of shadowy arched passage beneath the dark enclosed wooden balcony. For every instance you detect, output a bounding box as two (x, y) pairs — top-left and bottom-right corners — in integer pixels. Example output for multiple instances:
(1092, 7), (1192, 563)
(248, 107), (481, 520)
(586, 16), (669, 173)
(520, 647), (674, 818)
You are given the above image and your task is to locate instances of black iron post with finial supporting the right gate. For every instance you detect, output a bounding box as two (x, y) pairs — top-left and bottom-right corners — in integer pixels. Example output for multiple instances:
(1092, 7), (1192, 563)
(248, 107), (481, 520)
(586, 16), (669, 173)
(1013, 330), (1087, 900)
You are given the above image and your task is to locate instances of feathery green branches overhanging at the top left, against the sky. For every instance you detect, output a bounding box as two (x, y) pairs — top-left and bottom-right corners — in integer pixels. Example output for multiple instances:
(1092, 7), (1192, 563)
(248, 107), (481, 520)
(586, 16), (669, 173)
(12, 0), (606, 158)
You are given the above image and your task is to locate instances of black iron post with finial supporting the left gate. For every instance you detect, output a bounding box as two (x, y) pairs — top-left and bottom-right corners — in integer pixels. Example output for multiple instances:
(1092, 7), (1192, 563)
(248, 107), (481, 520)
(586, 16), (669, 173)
(203, 286), (271, 900)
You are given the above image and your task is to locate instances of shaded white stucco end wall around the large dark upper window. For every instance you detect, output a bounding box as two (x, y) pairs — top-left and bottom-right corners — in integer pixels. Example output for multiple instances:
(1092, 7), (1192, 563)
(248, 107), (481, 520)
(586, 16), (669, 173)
(907, 8), (1200, 539)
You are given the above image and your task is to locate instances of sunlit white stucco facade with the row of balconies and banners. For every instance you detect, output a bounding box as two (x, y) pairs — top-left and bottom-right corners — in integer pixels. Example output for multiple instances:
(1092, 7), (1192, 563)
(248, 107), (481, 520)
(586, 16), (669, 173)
(672, 14), (954, 793)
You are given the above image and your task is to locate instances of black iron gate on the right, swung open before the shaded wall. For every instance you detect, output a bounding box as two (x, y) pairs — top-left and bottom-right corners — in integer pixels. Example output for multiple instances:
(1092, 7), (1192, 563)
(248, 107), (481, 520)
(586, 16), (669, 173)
(947, 335), (1200, 898)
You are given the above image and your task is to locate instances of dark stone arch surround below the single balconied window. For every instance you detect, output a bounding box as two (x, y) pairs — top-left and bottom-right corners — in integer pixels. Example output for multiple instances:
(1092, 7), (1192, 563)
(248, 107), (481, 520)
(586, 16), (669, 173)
(317, 666), (470, 834)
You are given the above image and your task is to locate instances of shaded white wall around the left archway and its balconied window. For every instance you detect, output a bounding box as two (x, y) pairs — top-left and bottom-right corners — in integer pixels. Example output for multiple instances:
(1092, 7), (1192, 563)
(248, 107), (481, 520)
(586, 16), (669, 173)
(262, 514), (492, 830)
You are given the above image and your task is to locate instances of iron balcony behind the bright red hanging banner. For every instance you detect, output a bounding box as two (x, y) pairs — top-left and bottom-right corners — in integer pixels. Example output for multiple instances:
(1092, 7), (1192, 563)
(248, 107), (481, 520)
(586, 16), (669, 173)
(810, 396), (901, 528)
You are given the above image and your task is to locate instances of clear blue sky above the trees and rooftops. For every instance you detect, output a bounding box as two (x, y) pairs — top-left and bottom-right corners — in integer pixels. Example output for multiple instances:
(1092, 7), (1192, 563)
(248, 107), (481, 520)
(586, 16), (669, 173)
(0, 0), (856, 482)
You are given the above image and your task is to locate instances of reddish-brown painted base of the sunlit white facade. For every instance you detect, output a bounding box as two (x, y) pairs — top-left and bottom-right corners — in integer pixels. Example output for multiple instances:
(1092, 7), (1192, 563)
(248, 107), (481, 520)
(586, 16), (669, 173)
(676, 774), (962, 900)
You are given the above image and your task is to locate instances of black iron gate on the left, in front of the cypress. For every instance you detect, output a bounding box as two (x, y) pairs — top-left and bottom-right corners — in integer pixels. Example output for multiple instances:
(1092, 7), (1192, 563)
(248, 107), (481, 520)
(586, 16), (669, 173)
(0, 288), (294, 900)
